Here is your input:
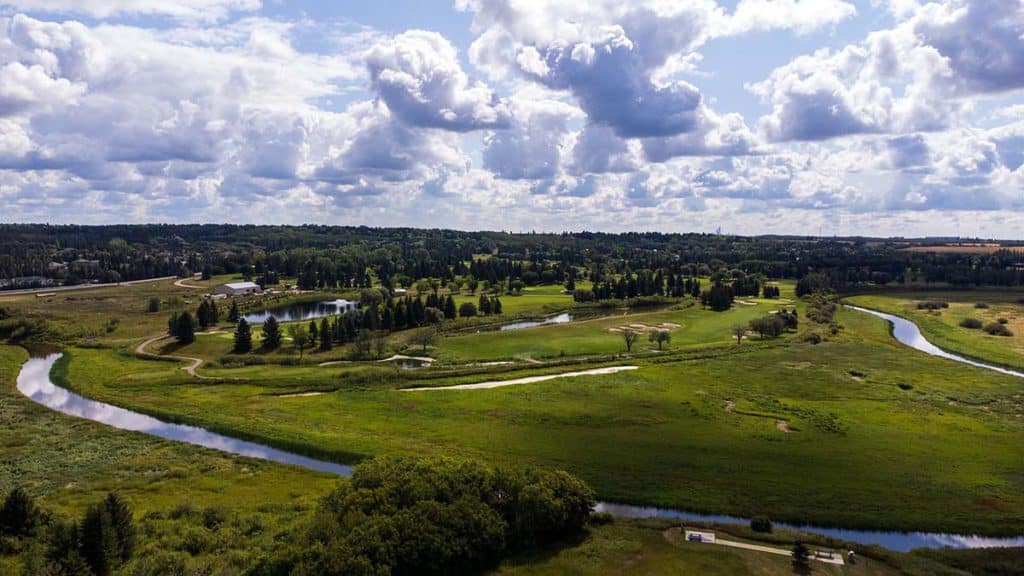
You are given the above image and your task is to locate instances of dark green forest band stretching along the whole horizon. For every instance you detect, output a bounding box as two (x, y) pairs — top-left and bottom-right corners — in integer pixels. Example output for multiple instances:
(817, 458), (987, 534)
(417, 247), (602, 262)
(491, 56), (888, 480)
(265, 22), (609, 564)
(0, 224), (1024, 289)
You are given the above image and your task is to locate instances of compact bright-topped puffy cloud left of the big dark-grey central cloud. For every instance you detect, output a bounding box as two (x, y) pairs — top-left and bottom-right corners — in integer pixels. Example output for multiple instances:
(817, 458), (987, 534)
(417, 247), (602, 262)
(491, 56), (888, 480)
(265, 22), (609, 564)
(367, 31), (508, 131)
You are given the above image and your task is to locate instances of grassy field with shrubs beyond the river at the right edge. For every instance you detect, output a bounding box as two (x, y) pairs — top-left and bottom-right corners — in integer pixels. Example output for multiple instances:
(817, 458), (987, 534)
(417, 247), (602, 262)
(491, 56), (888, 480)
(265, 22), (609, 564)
(846, 290), (1024, 368)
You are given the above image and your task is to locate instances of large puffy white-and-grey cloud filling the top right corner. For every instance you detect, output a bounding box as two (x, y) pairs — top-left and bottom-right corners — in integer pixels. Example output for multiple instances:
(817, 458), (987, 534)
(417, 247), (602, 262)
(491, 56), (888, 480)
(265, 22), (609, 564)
(748, 0), (1024, 141)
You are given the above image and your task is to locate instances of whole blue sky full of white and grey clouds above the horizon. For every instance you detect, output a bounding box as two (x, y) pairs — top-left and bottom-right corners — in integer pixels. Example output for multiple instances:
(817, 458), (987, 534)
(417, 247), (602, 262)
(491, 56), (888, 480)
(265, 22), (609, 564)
(0, 0), (1024, 239)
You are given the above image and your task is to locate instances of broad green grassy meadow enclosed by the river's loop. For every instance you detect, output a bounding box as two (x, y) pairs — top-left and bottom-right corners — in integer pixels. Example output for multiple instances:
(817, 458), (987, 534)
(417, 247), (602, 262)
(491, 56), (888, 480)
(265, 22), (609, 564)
(48, 306), (1024, 533)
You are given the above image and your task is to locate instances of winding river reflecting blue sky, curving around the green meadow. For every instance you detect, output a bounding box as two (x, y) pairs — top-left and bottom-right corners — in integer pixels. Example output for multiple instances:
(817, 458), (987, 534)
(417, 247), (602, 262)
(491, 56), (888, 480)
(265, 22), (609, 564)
(17, 306), (1024, 551)
